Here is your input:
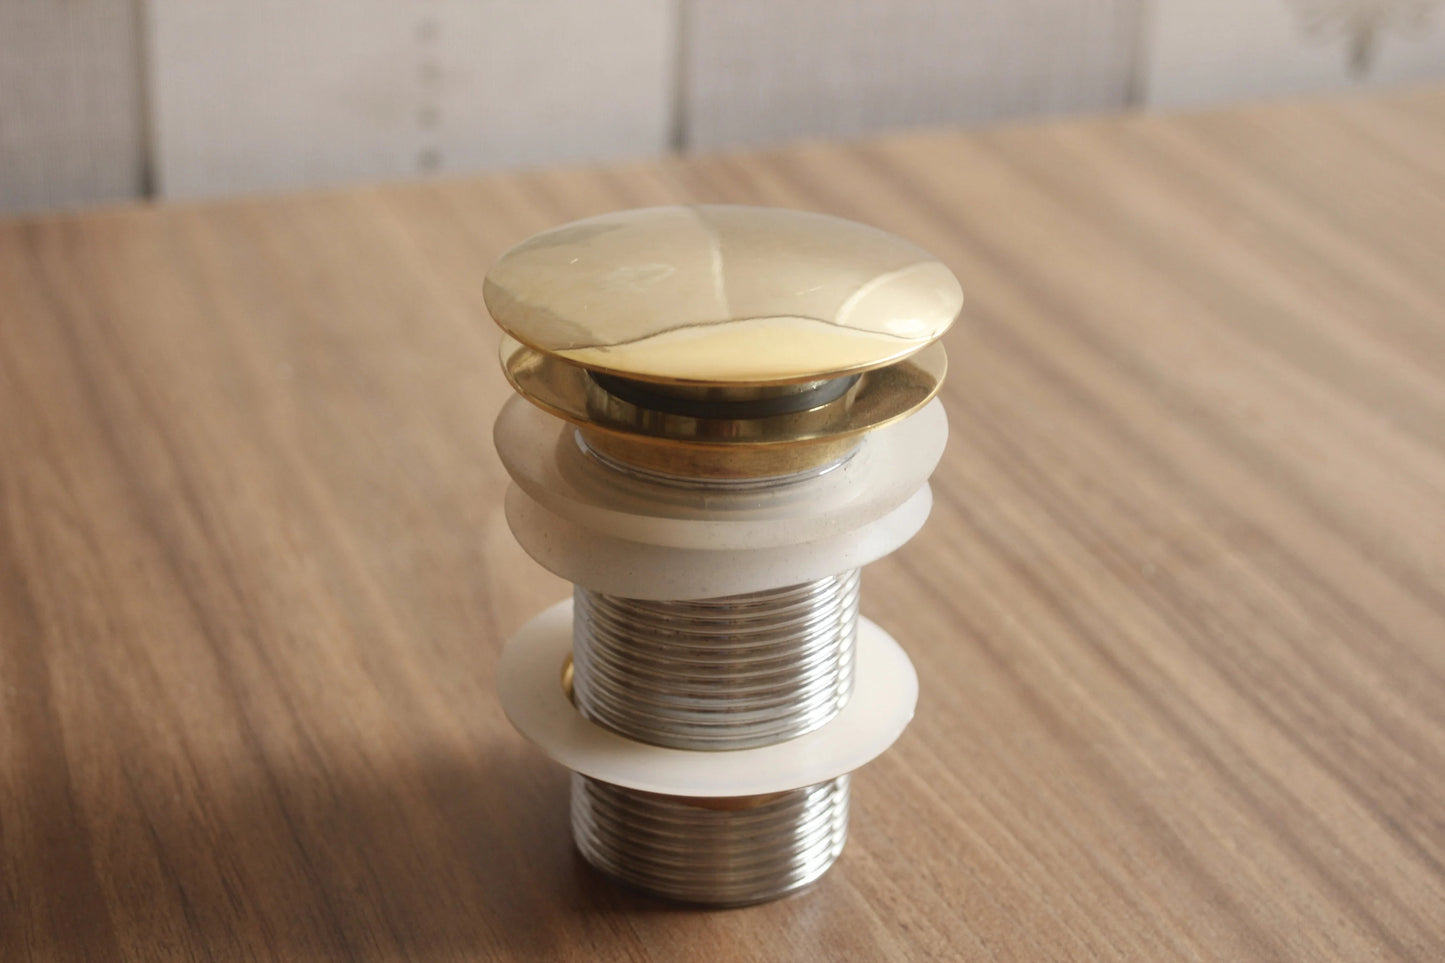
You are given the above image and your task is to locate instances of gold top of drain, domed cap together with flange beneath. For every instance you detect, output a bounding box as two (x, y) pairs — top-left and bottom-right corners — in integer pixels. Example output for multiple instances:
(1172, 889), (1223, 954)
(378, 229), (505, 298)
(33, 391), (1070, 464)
(483, 205), (962, 477)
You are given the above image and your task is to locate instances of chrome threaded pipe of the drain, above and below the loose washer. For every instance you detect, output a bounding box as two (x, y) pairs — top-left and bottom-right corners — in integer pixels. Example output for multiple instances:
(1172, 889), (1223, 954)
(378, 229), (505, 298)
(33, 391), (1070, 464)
(572, 568), (860, 905)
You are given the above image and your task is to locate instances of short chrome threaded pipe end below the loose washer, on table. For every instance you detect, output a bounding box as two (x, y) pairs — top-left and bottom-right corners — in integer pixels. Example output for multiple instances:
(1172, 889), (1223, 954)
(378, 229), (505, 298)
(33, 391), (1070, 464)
(572, 774), (848, 905)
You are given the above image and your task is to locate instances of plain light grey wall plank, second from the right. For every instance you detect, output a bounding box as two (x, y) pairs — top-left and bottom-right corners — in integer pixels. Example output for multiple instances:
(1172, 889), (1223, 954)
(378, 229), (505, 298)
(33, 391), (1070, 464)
(685, 0), (1143, 147)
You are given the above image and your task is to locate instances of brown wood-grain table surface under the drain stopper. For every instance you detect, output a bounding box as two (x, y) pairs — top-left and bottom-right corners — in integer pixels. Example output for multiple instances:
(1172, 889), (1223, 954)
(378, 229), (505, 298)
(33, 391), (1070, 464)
(0, 90), (1445, 963)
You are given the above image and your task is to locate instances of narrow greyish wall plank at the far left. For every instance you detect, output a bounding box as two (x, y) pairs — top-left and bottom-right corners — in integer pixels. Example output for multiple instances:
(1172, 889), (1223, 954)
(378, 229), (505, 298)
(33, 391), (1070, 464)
(0, 0), (145, 213)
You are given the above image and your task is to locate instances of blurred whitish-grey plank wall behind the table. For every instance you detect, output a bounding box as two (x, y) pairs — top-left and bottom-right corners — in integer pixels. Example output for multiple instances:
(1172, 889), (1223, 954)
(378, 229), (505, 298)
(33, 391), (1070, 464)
(0, 0), (1445, 213)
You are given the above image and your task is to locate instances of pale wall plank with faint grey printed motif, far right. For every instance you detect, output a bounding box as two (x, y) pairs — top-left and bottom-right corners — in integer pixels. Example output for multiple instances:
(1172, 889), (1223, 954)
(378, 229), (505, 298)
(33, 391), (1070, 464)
(1144, 0), (1445, 107)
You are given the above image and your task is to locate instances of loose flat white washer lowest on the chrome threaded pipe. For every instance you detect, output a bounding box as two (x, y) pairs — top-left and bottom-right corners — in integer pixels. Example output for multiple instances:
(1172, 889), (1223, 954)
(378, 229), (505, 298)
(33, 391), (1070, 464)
(497, 600), (918, 798)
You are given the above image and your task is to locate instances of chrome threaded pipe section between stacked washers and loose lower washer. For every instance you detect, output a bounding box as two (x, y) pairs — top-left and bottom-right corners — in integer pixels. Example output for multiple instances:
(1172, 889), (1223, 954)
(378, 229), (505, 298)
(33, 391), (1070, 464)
(572, 568), (858, 750)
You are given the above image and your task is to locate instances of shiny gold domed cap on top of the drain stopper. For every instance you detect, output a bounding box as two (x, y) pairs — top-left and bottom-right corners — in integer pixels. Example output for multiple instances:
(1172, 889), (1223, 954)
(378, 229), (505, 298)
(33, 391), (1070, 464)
(483, 205), (964, 385)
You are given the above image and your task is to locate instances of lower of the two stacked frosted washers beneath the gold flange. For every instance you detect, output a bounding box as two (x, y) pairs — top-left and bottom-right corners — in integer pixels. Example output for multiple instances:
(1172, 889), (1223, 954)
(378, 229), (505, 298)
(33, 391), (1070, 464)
(506, 483), (933, 600)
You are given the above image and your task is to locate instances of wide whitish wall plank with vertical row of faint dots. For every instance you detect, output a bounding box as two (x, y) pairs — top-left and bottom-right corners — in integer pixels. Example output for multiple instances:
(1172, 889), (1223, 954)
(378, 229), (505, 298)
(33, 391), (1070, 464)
(149, 0), (676, 197)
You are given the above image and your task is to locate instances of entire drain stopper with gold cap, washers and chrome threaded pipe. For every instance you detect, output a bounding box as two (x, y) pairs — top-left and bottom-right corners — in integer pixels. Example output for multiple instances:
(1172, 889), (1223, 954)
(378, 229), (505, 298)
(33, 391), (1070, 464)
(484, 207), (962, 905)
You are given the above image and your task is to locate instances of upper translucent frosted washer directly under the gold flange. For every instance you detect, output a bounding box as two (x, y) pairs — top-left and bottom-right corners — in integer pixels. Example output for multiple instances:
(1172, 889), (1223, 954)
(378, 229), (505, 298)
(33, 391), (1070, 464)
(493, 398), (948, 551)
